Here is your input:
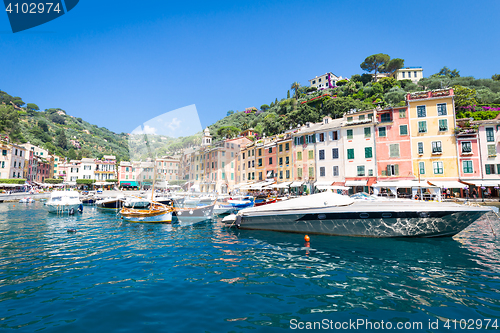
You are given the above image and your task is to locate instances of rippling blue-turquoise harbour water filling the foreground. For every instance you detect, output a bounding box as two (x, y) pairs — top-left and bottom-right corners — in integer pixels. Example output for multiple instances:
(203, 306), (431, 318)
(0, 203), (500, 332)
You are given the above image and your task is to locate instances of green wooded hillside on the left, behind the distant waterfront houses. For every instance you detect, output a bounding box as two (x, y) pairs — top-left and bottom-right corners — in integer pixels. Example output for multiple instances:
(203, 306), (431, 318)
(0, 91), (129, 160)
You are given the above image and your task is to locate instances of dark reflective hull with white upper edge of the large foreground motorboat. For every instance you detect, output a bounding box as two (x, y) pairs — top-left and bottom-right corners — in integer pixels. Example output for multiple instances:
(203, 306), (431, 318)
(226, 203), (489, 237)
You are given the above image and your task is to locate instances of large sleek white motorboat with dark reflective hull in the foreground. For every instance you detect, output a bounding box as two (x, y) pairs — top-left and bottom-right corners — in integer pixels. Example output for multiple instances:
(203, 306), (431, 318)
(223, 192), (490, 237)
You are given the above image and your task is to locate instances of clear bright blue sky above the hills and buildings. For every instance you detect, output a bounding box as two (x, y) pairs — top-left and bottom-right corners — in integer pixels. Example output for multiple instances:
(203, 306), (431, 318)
(0, 0), (500, 133)
